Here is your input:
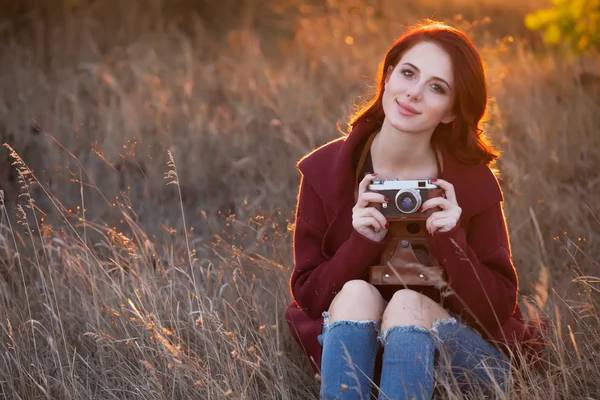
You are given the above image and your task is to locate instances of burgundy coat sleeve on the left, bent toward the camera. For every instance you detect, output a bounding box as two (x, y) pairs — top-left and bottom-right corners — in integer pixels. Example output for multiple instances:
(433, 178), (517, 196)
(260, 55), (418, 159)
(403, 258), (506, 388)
(290, 177), (387, 319)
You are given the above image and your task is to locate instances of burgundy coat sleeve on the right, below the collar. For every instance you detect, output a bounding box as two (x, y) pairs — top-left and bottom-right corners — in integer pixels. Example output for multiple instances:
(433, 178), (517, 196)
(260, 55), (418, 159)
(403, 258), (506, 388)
(430, 202), (518, 333)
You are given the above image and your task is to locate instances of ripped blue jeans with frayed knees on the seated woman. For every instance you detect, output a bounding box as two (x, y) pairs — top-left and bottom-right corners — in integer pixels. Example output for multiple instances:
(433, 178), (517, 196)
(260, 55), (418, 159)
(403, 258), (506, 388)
(318, 312), (510, 400)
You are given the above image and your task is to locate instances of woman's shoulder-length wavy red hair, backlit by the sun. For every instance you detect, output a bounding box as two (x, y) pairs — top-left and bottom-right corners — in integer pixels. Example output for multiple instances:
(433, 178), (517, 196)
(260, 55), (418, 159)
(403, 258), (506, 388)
(350, 22), (499, 165)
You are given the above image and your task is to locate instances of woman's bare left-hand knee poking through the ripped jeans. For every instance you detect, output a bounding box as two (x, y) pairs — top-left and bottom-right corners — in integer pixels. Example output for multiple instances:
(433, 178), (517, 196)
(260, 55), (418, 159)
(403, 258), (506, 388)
(329, 280), (385, 321)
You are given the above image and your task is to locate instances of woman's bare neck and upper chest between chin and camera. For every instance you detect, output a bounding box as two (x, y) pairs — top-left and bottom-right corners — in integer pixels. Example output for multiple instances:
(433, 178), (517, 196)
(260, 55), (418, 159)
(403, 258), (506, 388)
(371, 120), (437, 179)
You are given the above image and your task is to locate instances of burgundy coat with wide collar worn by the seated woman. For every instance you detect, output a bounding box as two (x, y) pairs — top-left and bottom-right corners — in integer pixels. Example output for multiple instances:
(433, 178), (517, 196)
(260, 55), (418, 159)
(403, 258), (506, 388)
(286, 122), (534, 372)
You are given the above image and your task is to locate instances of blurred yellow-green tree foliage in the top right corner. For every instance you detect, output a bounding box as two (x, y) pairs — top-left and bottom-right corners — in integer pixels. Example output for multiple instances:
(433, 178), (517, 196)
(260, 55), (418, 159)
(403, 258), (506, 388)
(525, 0), (600, 53)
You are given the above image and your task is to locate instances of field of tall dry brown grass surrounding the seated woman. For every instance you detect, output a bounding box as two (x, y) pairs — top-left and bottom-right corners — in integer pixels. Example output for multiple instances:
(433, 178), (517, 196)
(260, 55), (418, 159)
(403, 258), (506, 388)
(0, 0), (600, 400)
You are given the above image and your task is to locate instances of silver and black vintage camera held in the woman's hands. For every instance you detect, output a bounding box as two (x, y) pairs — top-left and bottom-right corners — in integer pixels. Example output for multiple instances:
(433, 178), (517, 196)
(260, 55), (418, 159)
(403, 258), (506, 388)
(369, 178), (444, 221)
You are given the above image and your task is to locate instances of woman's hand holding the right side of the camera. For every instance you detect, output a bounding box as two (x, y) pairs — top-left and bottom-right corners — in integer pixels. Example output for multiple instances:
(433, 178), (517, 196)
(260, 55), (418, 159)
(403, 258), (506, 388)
(421, 179), (462, 235)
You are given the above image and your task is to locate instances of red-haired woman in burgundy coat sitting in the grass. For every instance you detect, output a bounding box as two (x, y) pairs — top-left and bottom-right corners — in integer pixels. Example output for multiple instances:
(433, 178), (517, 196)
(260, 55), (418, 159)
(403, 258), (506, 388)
(286, 23), (535, 399)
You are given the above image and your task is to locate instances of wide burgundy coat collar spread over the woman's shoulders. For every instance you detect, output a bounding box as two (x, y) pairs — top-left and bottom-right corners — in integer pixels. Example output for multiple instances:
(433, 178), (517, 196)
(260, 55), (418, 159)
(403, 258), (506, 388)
(297, 120), (502, 216)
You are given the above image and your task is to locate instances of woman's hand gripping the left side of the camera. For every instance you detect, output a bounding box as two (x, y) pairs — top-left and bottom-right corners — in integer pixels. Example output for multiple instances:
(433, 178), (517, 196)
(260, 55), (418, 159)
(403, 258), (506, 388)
(352, 174), (390, 242)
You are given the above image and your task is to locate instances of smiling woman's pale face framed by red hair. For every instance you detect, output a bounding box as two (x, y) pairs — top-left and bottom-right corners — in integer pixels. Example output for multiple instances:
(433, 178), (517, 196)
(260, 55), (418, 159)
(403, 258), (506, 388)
(382, 42), (456, 133)
